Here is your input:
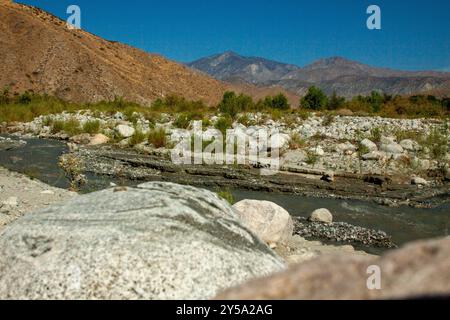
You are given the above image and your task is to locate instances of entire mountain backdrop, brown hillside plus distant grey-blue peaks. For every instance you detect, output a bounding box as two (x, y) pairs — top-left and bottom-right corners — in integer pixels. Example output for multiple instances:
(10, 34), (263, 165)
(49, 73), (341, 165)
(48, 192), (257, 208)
(0, 0), (450, 105)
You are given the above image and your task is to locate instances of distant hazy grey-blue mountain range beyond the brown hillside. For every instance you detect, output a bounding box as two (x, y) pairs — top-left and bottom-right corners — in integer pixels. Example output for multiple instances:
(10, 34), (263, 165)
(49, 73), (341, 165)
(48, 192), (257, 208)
(188, 52), (450, 97)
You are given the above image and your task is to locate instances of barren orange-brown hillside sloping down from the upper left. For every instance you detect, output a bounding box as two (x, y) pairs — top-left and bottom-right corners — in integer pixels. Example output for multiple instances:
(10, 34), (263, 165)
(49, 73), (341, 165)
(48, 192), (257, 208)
(0, 0), (227, 104)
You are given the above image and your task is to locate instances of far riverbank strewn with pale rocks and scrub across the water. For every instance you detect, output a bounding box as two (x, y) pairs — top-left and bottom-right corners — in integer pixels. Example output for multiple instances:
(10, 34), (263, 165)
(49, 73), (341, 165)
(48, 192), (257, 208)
(3, 111), (450, 207)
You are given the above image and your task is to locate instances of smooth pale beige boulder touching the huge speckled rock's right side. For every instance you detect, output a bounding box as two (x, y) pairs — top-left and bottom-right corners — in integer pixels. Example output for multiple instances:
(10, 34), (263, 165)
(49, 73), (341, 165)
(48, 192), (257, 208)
(233, 200), (294, 243)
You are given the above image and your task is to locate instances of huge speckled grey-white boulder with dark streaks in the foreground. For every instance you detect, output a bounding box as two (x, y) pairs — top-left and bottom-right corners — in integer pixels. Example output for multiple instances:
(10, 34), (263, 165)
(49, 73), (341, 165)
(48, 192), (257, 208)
(0, 182), (284, 299)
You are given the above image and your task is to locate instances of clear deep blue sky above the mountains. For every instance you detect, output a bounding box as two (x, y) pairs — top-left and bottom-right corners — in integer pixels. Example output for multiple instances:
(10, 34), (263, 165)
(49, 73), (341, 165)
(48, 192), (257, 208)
(18, 0), (450, 71)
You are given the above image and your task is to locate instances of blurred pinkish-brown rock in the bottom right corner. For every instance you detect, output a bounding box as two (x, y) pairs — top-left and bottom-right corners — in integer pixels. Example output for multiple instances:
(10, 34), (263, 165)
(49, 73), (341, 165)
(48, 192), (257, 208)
(218, 238), (450, 300)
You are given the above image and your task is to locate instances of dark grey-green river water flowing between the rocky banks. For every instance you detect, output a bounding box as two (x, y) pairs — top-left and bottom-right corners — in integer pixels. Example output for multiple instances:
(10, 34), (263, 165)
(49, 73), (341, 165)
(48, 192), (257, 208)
(0, 135), (450, 252)
